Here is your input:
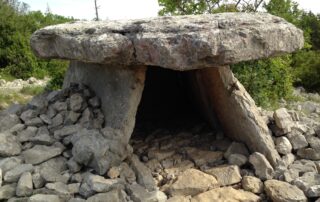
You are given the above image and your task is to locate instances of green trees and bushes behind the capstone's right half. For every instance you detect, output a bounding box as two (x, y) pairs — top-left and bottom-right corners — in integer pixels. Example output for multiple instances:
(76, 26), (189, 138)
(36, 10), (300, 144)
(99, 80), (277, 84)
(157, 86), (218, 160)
(159, 0), (320, 107)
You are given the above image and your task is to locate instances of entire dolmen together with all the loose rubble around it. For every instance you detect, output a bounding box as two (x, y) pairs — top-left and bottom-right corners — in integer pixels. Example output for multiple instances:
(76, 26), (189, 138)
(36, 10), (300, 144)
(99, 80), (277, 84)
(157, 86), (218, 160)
(0, 13), (320, 202)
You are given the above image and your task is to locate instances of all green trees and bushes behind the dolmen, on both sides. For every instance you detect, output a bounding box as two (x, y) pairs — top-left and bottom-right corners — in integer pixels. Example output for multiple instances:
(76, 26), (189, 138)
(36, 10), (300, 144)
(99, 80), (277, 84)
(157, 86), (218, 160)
(0, 0), (320, 107)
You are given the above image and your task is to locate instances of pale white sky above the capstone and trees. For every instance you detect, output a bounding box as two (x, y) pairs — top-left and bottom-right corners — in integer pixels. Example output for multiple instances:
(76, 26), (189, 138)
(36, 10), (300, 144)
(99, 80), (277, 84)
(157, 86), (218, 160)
(21, 0), (320, 20)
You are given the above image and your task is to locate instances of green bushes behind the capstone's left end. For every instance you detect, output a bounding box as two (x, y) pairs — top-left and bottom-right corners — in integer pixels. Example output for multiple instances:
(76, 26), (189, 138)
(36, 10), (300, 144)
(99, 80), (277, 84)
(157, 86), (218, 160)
(0, 0), (73, 88)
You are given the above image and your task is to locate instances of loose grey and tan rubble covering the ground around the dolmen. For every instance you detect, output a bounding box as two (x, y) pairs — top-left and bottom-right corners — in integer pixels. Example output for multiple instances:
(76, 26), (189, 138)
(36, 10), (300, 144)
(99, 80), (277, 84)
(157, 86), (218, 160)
(0, 84), (320, 202)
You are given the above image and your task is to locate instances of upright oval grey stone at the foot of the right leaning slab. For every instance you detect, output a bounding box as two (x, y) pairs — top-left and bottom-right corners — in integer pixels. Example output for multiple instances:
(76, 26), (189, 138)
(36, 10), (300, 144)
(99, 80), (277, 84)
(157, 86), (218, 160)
(249, 152), (274, 180)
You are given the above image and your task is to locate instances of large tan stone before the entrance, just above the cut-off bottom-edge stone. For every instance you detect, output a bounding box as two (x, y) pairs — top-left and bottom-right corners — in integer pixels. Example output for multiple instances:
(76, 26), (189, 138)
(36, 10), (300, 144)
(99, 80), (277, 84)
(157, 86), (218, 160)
(169, 168), (218, 196)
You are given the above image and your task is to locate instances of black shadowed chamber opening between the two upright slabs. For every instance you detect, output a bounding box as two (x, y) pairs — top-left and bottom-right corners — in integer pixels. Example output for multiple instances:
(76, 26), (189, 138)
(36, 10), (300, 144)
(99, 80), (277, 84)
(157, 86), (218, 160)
(133, 67), (212, 137)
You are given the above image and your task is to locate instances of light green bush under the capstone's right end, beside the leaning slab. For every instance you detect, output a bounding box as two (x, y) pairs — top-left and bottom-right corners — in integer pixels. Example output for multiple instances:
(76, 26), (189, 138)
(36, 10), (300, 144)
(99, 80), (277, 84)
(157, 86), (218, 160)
(232, 55), (293, 108)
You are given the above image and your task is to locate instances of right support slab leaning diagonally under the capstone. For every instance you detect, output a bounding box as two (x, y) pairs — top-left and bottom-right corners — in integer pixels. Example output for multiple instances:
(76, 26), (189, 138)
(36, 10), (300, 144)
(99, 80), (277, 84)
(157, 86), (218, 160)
(193, 66), (280, 166)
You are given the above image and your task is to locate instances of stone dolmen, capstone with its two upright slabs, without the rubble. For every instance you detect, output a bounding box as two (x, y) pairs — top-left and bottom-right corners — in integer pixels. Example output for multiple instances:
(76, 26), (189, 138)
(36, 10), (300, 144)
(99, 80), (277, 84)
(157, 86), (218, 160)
(31, 13), (304, 166)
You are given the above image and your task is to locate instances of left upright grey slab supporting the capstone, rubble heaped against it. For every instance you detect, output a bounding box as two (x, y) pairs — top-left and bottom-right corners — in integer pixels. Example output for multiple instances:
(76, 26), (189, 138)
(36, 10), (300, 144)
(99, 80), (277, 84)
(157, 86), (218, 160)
(63, 61), (146, 143)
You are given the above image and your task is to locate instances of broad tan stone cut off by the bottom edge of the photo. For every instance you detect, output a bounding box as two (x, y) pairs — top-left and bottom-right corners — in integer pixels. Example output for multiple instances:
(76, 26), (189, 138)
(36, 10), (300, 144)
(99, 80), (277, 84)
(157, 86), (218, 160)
(191, 187), (260, 202)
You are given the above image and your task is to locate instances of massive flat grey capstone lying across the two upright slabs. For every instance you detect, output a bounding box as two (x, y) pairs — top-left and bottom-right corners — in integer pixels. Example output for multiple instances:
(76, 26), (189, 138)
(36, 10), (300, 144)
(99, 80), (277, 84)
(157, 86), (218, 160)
(31, 13), (304, 70)
